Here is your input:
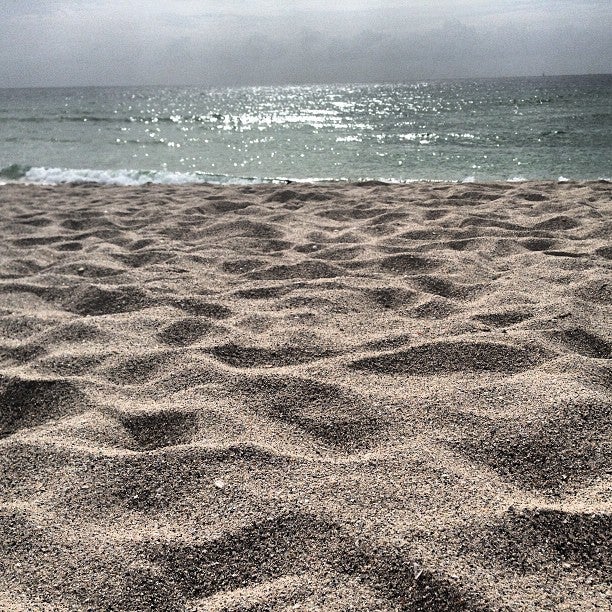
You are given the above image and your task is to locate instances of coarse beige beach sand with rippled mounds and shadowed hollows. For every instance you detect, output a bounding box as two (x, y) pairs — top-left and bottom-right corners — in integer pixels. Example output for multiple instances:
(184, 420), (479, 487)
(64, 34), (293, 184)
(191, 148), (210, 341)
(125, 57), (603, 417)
(0, 182), (612, 611)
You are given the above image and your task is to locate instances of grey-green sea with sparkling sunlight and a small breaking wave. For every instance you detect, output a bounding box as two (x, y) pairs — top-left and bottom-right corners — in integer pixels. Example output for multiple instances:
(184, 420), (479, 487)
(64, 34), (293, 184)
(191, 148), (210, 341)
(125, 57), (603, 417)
(0, 75), (612, 185)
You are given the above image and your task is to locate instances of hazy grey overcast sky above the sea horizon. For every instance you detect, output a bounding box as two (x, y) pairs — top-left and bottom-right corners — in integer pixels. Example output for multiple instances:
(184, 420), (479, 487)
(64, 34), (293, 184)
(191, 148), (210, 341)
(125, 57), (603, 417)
(0, 0), (612, 87)
